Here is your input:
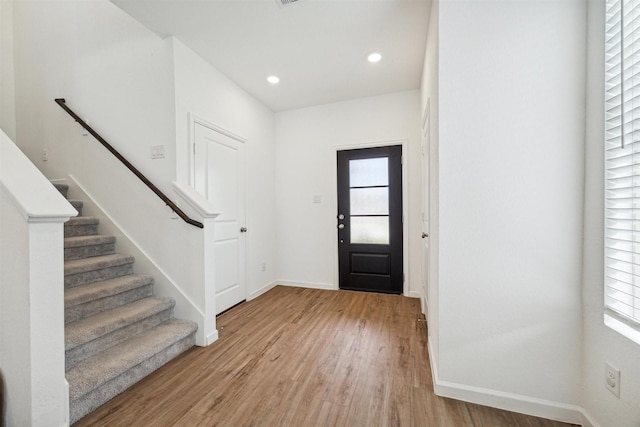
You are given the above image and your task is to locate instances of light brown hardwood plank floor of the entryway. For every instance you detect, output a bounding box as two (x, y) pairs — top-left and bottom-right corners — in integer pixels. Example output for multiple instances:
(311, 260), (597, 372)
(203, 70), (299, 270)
(75, 286), (580, 427)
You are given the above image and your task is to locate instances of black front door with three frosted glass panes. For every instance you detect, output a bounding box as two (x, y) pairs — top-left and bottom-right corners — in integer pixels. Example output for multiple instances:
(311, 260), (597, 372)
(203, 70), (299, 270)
(338, 145), (403, 294)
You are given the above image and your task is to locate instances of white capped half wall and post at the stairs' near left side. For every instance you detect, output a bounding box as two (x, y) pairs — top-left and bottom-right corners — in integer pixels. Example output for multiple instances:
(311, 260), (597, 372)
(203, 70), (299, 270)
(0, 131), (77, 426)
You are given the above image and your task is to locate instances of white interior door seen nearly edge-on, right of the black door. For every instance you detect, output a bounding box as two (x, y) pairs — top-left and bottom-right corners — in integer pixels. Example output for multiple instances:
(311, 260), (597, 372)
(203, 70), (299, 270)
(421, 102), (430, 315)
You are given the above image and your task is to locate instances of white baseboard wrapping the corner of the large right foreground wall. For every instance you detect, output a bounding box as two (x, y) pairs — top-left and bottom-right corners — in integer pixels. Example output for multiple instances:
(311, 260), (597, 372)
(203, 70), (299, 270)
(429, 340), (588, 427)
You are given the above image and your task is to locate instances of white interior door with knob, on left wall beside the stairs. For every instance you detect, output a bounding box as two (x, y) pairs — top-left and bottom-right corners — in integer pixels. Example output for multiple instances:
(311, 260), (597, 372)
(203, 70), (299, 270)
(193, 122), (247, 314)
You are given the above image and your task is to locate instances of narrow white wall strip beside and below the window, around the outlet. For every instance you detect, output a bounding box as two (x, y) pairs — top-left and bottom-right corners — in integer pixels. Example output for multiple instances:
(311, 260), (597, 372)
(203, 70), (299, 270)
(582, 0), (640, 427)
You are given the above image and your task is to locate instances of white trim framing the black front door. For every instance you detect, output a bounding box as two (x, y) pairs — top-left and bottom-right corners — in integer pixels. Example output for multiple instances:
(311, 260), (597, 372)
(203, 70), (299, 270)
(329, 139), (410, 296)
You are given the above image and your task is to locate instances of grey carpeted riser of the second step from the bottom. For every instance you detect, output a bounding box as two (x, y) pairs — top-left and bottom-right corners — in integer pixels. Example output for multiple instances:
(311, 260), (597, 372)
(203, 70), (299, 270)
(65, 308), (173, 370)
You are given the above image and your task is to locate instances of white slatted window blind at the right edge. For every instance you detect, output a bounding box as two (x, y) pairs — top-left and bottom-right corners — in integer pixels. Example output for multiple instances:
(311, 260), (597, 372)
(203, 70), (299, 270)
(605, 0), (640, 324)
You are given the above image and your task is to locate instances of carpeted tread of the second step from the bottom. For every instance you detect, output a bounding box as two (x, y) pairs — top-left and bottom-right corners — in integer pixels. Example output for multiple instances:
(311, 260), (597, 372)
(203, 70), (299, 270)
(65, 297), (175, 351)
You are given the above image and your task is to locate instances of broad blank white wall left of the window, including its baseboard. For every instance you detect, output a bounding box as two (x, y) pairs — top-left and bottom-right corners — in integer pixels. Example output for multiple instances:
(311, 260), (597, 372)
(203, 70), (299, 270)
(435, 0), (586, 420)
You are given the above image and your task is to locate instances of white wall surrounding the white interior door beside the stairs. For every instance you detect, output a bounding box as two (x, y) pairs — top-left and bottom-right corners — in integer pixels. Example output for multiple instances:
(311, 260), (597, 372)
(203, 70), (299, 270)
(172, 39), (276, 298)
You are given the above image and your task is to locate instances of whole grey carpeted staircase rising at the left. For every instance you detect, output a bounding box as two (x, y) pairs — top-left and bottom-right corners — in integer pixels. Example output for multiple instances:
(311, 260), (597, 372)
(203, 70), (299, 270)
(55, 184), (197, 423)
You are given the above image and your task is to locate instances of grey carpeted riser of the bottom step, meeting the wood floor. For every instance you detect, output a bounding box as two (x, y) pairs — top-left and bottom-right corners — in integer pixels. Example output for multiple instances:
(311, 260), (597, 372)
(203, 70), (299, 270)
(69, 332), (195, 424)
